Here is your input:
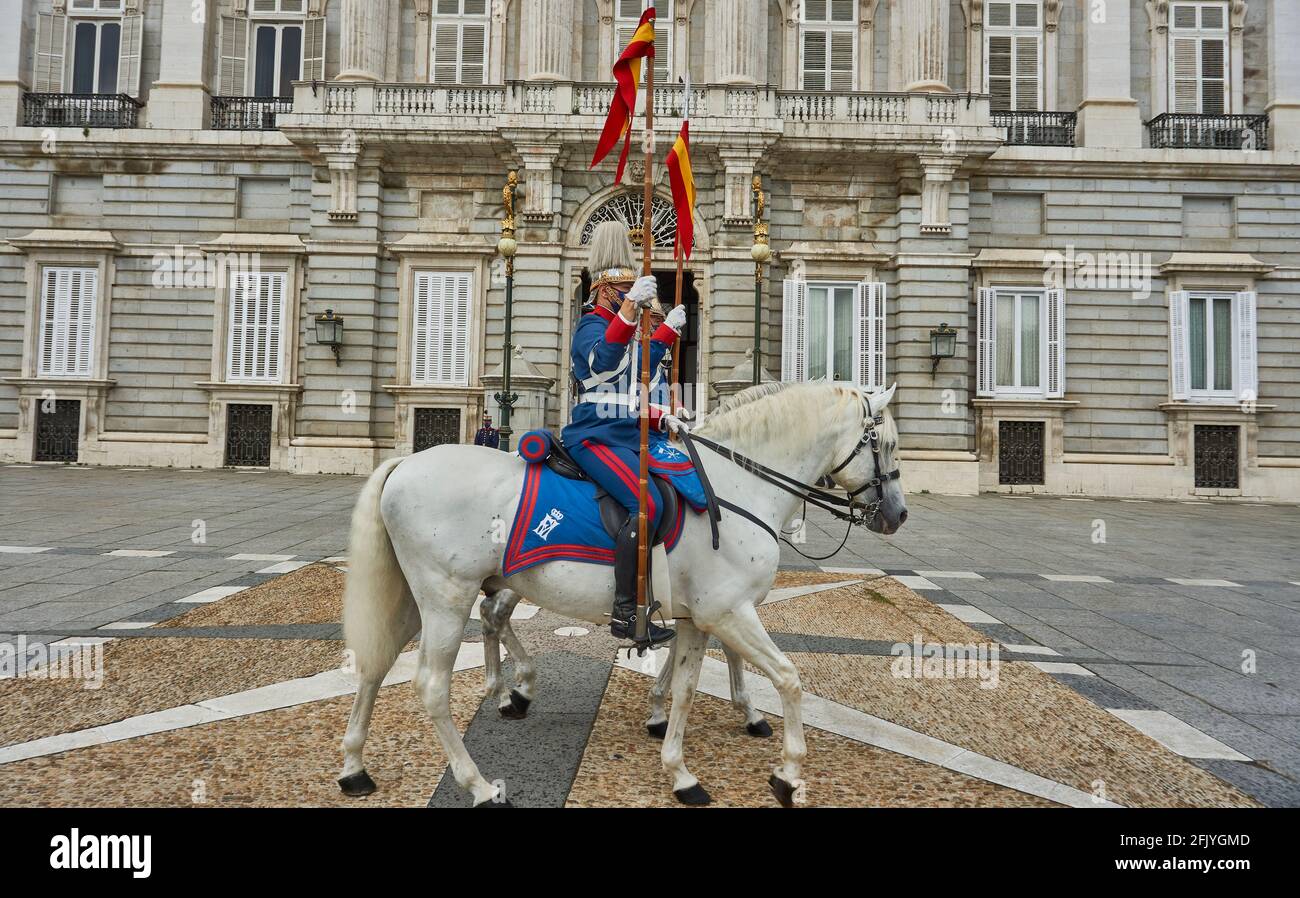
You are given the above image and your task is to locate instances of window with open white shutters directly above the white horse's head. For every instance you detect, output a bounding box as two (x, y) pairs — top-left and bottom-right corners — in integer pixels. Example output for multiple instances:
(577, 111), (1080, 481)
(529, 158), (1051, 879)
(781, 278), (885, 389)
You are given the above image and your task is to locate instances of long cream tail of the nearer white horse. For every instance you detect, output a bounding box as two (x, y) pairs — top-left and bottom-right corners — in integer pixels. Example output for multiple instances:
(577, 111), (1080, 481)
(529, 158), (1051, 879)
(343, 457), (419, 681)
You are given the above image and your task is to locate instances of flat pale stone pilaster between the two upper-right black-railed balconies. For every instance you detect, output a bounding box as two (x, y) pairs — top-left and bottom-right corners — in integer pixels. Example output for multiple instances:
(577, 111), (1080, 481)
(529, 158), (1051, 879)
(1079, 3), (1141, 147)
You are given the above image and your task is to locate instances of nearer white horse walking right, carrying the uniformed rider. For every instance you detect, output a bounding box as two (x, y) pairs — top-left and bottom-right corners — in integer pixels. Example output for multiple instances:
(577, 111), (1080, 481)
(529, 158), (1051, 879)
(339, 382), (907, 807)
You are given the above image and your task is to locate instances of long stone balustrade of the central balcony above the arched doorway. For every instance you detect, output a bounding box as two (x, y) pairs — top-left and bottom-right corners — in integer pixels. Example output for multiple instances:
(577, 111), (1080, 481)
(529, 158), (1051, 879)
(278, 82), (1005, 152)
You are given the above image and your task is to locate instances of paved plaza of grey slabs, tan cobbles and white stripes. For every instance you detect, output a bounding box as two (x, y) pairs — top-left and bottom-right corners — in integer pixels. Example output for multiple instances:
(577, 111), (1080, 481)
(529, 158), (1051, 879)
(0, 465), (1300, 806)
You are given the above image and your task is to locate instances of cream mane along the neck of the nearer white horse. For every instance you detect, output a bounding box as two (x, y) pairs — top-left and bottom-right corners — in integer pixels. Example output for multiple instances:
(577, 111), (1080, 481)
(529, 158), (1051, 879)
(697, 381), (898, 444)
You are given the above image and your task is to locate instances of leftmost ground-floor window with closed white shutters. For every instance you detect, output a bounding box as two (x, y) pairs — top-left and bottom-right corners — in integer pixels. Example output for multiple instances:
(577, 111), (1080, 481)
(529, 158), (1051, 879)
(36, 266), (99, 377)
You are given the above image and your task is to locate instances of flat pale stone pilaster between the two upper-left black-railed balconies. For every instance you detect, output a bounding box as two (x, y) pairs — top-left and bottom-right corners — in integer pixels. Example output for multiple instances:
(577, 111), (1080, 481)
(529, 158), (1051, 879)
(148, 0), (211, 130)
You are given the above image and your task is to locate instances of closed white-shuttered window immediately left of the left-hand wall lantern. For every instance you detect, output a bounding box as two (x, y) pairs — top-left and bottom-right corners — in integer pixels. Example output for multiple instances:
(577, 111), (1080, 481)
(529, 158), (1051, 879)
(226, 272), (289, 383)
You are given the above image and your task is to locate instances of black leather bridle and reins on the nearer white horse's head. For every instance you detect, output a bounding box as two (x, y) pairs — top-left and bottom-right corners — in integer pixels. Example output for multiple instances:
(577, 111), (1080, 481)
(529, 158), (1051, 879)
(681, 399), (901, 560)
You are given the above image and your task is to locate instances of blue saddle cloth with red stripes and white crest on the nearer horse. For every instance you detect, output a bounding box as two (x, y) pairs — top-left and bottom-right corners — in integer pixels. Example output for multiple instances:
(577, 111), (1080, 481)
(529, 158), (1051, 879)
(501, 430), (706, 577)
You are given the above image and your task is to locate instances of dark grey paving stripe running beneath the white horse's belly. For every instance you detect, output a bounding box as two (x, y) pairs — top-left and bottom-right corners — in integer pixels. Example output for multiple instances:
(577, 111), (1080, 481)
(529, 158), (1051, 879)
(429, 651), (608, 807)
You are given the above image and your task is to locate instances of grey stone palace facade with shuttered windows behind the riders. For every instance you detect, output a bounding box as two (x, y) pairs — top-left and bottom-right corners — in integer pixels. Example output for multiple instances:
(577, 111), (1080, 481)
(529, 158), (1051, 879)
(0, 0), (1300, 500)
